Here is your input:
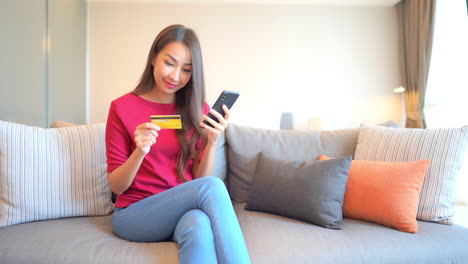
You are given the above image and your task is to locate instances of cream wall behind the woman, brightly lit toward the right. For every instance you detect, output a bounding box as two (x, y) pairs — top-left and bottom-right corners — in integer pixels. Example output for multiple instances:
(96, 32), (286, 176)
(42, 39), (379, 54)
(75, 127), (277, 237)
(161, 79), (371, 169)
(88, 2), (402, 129)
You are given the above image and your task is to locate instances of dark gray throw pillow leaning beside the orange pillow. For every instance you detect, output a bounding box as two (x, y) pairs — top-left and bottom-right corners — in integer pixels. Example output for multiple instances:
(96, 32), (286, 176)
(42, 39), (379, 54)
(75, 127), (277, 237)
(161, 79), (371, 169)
(245, 153), (351, 229)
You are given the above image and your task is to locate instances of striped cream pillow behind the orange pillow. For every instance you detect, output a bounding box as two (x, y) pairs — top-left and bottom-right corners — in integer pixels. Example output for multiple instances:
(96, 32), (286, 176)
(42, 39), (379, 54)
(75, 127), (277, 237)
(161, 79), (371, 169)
(355, 125), (468, 225)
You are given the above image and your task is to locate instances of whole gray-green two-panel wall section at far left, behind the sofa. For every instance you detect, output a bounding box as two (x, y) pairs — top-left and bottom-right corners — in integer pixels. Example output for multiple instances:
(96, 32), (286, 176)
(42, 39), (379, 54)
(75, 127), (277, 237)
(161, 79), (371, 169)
(0, 0), (87, 127)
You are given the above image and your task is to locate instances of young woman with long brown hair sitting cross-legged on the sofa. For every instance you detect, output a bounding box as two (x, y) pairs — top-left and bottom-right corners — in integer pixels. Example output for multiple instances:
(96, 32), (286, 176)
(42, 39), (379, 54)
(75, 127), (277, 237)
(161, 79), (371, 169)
(106, 25), (250, 264)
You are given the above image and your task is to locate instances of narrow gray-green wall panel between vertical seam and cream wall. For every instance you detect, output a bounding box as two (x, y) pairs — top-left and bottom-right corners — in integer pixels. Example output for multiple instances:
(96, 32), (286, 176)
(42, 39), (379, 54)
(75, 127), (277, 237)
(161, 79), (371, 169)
(47, 0), (87, 126)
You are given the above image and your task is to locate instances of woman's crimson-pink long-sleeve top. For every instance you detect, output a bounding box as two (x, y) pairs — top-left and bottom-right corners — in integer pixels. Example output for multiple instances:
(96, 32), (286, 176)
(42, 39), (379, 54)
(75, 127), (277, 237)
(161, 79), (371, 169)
(106, 94), (209, 207)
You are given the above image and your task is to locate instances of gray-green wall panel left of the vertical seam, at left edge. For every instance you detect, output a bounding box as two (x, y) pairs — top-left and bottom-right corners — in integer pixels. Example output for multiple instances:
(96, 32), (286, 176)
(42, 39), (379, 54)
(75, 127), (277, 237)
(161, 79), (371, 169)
(0, 0), (47, 127)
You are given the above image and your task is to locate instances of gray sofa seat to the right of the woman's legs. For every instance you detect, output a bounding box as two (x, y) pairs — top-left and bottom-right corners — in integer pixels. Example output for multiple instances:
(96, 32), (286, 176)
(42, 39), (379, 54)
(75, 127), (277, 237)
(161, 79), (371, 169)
(235, 203), (468, 264)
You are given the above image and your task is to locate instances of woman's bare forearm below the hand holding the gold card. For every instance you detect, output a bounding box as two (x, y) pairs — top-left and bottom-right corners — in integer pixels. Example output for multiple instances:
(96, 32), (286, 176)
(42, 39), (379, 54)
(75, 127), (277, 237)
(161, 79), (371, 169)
(107, 148), (145, 194)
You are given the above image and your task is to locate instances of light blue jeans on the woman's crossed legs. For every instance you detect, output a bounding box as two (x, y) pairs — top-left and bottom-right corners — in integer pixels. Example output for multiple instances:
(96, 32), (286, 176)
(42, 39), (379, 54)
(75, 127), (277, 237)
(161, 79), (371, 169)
(112, 177), (250, 264)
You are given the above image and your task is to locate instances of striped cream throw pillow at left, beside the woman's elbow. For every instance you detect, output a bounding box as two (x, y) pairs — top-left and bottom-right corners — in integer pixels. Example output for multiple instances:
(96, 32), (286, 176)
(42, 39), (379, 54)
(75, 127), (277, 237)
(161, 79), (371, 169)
(0, 121), (112, 227)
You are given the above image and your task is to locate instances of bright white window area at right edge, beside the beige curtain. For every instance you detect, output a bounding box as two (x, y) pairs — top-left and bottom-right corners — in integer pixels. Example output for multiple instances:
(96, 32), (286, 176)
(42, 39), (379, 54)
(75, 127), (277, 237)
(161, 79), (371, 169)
(424, 0), (468, 227)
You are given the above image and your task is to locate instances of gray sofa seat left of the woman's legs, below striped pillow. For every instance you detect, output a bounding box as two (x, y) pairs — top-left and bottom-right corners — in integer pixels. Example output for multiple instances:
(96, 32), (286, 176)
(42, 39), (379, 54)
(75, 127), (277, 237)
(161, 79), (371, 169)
(0, 216), (178, 264)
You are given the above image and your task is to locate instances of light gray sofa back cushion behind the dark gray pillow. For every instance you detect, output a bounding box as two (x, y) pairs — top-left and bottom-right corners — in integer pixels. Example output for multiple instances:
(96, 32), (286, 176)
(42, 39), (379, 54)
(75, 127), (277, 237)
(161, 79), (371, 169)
(226, 124), (359, 202)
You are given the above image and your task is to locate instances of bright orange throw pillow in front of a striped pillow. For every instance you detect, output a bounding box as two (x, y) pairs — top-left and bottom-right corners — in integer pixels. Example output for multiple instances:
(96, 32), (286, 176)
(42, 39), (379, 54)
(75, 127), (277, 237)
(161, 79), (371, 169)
(319, 155), (429, 233)
